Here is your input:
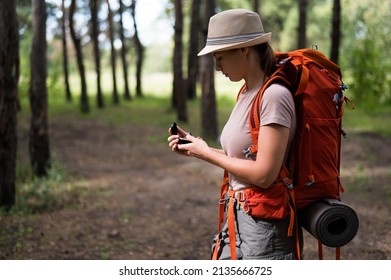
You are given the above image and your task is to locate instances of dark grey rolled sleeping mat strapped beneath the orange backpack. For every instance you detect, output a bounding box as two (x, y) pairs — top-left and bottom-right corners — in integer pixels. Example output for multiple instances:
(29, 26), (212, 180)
(299, 199), (359, 247)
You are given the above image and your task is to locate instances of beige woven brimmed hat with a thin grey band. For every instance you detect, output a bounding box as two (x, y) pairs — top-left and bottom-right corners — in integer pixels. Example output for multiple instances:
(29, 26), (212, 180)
(198, 9), (272, 56)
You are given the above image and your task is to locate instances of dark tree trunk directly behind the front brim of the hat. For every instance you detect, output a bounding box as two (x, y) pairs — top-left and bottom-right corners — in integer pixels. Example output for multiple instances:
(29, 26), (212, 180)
(201, 0), (218, 140)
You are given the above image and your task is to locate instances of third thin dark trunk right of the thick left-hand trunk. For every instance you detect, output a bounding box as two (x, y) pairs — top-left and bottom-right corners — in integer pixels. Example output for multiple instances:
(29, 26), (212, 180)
(90, 0), (104, 108)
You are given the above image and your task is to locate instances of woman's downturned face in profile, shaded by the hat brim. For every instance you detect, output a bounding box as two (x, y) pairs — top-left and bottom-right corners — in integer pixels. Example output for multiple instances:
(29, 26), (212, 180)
(213, 49), (247, 82)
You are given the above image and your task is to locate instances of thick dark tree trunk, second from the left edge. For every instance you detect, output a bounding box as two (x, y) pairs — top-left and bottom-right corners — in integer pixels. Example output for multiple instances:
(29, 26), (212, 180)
(29, 0), (50, 177)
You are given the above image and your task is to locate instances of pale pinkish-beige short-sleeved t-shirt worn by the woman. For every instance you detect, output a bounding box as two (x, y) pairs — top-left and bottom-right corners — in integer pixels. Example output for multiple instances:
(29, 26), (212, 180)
(220, 84), (296, 190)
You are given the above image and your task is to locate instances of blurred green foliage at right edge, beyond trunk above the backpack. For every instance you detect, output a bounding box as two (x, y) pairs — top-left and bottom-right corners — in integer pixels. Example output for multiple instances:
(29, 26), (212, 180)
(343, 0), (391, 105)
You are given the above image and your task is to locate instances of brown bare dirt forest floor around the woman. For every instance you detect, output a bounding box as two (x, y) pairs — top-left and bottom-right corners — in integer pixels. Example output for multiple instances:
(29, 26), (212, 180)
(0, 115), (391, 260)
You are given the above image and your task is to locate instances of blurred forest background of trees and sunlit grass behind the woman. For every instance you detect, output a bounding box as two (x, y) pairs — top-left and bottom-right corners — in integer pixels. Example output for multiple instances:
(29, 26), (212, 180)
(0, 0), (391, 258)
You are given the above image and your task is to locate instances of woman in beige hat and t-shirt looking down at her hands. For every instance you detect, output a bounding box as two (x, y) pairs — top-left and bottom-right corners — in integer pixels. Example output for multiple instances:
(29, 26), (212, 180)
(168, 9), (297, 259)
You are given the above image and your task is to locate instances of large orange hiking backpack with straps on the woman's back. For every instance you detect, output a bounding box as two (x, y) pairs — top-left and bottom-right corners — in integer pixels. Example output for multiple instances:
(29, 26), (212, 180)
(213, 49), (349, 258)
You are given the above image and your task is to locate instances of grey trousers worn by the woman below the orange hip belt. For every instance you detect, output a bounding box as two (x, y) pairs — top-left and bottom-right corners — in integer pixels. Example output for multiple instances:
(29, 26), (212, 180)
(212, 202), (301, 260)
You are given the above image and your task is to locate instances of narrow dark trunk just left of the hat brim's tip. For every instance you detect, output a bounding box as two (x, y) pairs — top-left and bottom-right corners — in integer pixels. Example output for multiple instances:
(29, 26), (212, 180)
(186, 0), (201, 99)
